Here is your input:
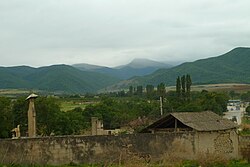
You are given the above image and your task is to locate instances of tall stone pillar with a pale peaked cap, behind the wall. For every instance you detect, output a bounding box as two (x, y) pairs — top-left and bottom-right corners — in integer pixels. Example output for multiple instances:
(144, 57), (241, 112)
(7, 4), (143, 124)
(26, 94), (38, 137)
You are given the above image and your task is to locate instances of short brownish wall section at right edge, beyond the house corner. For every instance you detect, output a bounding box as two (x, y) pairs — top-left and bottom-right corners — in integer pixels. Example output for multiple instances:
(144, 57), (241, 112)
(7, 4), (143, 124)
(239, 135), (250, 162)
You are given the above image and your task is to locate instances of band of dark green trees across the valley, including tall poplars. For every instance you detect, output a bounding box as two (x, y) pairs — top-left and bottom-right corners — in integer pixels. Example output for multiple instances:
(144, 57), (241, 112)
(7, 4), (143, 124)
(0, 75), (250, 138)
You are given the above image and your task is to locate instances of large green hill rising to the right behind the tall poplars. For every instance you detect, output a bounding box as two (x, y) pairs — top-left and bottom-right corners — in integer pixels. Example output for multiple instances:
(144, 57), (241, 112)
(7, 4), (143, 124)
(113, 47), (250, 88)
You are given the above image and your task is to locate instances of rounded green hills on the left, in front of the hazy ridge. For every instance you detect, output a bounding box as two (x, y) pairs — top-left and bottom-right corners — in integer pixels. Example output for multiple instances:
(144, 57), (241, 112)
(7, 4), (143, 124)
(0, 65), (119, 93)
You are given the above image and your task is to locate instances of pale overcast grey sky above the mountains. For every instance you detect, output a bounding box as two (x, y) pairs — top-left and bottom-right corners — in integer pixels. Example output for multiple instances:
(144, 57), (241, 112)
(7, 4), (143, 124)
(0, 0), (250, 67)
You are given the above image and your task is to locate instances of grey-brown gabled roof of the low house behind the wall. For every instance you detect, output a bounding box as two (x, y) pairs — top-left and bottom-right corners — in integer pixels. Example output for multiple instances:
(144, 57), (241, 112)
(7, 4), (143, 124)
(142, 111), (237, 132)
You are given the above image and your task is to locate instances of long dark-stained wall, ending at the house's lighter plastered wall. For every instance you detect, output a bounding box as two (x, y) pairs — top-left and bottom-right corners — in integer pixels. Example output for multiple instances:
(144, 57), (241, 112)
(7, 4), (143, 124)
(0, 133), (195, 165)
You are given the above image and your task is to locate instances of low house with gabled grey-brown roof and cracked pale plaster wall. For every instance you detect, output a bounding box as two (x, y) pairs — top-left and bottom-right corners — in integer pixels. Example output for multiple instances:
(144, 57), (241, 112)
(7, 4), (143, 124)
(141, 111), (238, 158)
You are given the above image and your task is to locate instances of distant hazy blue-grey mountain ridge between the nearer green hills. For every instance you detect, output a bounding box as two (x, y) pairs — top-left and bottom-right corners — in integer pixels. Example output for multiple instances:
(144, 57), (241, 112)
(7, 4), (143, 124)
(72, 59), (172, 79)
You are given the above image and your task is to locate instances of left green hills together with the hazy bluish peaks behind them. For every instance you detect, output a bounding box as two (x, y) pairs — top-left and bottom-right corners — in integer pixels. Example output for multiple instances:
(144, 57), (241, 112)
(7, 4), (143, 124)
(0, 59), (170, 94)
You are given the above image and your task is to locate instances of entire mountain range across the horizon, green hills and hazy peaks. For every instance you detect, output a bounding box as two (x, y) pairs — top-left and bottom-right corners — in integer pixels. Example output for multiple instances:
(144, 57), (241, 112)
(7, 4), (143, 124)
(0, 47), (250, 94)
